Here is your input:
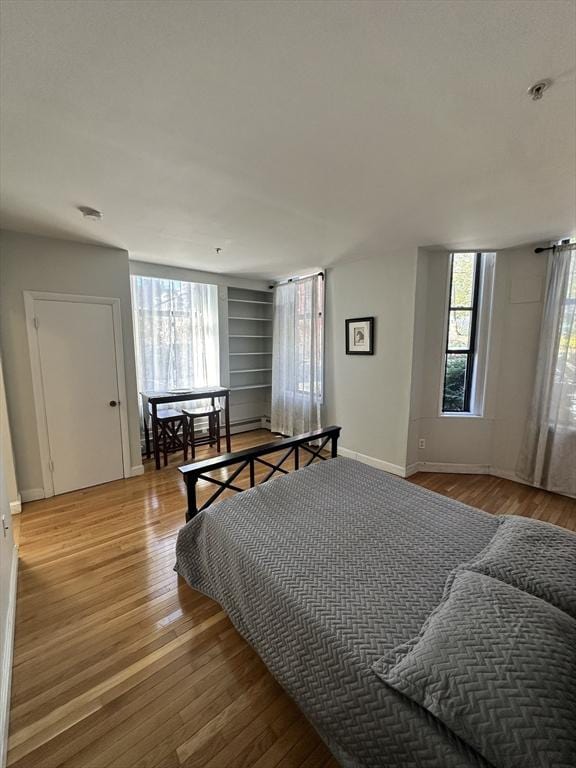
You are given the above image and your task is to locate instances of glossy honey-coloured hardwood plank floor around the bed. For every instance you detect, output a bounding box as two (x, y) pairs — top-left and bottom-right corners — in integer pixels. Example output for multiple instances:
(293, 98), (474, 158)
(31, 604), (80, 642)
(8, 431), (576, 768)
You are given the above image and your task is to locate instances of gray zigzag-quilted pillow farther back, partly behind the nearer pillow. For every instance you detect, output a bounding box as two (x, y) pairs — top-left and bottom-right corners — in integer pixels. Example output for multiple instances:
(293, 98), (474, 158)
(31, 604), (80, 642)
(463, 516), (576, 619)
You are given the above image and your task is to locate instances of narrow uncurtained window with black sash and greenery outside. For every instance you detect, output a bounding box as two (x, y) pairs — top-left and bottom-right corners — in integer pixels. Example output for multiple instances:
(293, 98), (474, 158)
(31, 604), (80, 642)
(442, 253), (483, 413)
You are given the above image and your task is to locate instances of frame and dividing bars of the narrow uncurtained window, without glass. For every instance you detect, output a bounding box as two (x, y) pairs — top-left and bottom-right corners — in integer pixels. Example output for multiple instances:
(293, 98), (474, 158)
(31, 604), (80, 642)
(440, 251), (485, 417)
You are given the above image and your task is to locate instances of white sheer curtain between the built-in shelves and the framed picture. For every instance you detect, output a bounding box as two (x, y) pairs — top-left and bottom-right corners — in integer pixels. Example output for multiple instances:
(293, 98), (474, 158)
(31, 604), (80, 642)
(271, 275), (324, 435)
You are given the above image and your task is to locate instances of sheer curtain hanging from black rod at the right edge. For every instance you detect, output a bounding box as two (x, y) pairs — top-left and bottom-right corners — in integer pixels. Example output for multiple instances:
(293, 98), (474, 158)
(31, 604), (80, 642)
(517, 244), (576, 496)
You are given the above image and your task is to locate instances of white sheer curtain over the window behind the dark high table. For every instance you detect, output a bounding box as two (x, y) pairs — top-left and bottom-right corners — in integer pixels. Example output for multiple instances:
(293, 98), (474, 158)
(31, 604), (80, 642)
(132, 275), (220, 391)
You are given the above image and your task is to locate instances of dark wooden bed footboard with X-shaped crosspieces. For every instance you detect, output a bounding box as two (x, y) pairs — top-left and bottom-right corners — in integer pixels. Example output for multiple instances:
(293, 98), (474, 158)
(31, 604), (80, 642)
(178, 427), (341, 522)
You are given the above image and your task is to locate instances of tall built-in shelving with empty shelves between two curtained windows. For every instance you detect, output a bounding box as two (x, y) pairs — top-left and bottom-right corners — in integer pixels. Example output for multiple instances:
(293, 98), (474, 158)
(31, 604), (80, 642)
(228, 287), (273, 429)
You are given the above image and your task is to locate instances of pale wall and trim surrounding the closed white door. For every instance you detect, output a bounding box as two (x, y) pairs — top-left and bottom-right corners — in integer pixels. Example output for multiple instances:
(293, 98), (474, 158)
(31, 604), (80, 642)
(0, 231), (141, 498)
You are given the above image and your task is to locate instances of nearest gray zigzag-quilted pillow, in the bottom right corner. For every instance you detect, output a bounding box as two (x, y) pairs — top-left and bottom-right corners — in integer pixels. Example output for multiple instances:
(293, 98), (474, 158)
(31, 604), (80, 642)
(372, 570), (576, 768)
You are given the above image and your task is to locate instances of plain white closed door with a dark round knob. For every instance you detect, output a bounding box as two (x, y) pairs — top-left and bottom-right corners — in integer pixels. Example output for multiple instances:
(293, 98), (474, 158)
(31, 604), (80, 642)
(34, 299), (124, 494)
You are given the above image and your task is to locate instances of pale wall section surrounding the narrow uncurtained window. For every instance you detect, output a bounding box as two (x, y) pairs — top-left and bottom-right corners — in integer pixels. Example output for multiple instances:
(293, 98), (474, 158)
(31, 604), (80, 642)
(407, 245), (547, 475)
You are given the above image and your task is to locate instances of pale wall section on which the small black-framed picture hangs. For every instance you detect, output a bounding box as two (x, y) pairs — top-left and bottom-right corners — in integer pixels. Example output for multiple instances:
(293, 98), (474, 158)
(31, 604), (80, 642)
(324, 249), (417, 472)
